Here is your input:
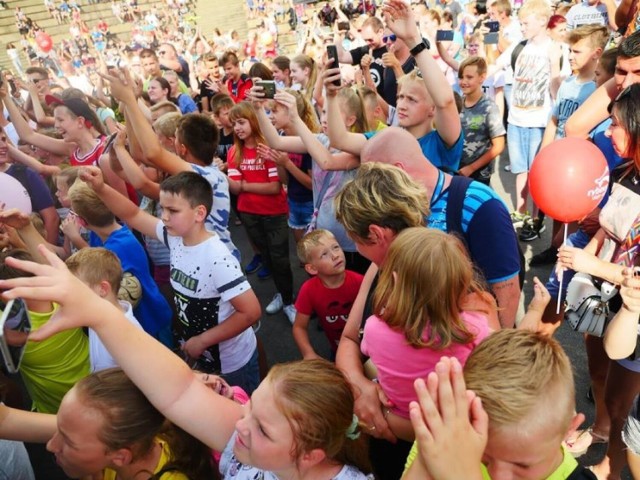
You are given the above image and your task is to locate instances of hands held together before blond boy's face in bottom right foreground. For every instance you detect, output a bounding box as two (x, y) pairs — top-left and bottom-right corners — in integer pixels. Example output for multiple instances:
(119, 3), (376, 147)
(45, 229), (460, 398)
(410, 357), (489, 480)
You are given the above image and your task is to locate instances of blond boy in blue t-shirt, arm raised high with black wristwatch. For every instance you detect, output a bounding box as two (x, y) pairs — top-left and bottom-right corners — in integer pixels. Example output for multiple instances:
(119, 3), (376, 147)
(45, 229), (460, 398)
(323, 0), (463, 171)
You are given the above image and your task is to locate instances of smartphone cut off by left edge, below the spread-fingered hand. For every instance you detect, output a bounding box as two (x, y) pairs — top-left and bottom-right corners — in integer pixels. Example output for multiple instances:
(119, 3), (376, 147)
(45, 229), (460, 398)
(0, 298), (31, 373)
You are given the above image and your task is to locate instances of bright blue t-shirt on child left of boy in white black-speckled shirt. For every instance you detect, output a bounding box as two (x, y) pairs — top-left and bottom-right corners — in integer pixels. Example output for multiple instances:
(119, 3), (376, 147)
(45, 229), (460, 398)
(89, 226), (173, 337)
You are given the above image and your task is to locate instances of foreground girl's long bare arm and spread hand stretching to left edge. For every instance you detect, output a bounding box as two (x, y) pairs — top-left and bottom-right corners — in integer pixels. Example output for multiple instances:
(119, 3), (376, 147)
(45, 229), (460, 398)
(0, 249), (243, 451)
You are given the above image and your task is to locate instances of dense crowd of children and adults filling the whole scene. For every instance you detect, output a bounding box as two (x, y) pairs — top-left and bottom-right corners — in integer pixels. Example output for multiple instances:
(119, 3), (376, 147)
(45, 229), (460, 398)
(0, 0), (640, 480)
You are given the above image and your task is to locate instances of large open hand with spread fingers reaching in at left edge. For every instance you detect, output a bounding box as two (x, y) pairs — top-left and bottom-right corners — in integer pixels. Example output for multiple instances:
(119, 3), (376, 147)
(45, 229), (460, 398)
(0, 245), (105, 341)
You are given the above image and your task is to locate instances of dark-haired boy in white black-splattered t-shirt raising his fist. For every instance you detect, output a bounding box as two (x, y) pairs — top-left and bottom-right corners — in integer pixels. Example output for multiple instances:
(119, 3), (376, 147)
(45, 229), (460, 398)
(80, 167), (261, 394)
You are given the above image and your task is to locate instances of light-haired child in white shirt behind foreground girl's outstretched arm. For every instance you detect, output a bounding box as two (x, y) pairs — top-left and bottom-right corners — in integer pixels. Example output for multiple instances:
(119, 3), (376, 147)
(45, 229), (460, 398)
(65, 247), (142, 372)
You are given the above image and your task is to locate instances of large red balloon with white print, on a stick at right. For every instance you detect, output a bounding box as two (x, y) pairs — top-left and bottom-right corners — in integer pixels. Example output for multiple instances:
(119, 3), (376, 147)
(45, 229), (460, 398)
(529, 138), (609, 223)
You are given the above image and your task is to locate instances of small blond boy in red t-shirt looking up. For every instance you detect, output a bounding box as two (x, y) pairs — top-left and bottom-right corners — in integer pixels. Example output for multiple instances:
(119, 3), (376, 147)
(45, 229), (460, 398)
(293, 230), (363, 360)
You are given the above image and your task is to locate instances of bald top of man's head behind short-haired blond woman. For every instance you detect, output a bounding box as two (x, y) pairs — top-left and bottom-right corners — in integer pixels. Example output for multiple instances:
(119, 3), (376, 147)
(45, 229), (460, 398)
(360, 127), (428, 165)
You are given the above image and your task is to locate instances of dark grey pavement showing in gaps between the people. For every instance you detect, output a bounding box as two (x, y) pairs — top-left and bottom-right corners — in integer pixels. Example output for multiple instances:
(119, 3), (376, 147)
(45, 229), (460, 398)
(231, 150), (631, 479)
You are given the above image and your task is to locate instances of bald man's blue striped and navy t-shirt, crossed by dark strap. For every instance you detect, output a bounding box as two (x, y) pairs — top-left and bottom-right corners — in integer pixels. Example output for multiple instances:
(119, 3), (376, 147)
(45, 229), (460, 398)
(427, 173), (520, 283)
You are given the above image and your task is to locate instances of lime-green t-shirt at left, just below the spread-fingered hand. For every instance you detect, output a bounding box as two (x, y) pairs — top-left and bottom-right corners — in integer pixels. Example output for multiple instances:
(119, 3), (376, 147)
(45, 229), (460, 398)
(20, 305), (91, 414)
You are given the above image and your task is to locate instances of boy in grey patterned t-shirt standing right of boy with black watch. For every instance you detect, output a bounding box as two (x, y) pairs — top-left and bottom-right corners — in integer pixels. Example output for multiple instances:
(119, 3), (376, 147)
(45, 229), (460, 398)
(458, 56), (507, 186)
